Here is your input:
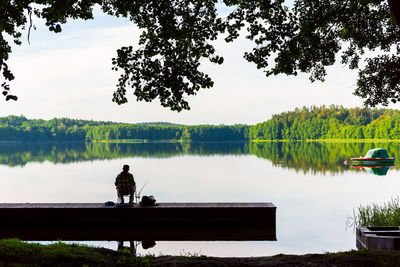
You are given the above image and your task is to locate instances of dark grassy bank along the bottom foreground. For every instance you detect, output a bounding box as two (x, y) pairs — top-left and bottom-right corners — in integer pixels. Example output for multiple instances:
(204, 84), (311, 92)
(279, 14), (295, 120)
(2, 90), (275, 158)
(0, 239), (400, 266)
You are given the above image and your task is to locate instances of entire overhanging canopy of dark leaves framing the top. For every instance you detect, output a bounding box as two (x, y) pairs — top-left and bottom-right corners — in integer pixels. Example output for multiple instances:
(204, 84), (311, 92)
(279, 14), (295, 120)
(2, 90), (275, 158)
(0, 0), (400, 111)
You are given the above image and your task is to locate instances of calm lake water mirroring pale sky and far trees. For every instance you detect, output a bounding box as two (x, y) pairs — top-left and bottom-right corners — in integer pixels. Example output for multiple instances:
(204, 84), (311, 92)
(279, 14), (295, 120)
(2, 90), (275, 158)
(0, 142), (400, 256)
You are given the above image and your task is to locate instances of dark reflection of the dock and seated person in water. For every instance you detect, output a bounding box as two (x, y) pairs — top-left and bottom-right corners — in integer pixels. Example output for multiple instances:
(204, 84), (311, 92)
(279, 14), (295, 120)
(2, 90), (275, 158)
(0, 225), (276, 256)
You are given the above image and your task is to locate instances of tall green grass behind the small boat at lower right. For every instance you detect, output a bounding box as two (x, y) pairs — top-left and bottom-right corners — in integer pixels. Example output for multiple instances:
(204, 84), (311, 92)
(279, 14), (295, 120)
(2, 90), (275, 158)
(350, 197), (400, 227)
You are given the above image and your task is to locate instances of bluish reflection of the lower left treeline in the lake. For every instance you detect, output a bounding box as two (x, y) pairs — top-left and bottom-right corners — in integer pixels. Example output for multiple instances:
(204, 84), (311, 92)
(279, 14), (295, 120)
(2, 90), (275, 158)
(0, 142), (249, 167)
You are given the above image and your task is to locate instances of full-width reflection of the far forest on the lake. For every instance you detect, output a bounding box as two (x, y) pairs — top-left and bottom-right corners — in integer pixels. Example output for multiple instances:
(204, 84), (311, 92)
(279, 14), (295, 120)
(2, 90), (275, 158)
(0, 142), (400, 174)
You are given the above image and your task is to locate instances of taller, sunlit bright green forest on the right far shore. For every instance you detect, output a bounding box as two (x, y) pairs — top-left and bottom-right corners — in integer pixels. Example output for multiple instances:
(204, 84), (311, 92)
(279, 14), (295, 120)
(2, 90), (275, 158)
(249, 105), (400, 140)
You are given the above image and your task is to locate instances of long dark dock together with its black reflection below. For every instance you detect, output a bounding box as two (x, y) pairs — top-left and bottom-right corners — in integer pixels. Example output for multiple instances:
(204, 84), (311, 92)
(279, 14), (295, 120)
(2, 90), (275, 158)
(0, 203), (276, 241)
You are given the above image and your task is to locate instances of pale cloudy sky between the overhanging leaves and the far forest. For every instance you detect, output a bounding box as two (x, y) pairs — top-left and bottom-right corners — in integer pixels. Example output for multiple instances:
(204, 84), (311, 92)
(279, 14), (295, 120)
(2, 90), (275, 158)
(0, 5), (397, 125)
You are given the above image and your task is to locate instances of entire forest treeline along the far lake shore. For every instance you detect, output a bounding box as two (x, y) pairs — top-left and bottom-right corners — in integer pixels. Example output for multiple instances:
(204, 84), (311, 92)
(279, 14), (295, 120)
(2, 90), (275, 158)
(0, 105), (400, 142)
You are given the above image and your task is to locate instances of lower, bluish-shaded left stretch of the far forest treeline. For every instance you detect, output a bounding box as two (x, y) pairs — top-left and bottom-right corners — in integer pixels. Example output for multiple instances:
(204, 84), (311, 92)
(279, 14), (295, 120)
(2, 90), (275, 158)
(0, 116), (249, 142)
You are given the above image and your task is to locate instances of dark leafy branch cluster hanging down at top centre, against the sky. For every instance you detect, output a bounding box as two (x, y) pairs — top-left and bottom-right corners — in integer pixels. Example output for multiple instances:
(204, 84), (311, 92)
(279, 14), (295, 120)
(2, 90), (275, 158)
(108, 0), (223, 111)
